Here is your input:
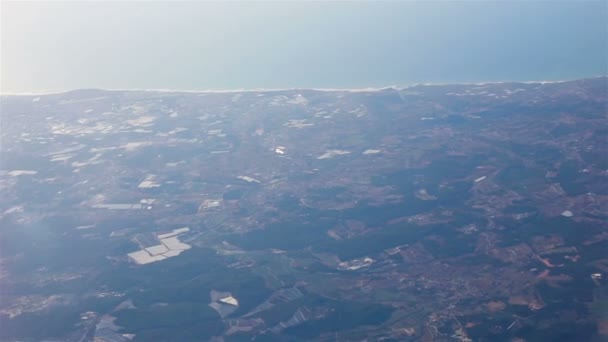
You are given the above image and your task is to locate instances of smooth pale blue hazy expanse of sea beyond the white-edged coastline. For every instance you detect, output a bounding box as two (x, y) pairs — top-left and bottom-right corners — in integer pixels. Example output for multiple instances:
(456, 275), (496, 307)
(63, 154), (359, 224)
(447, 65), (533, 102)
(0, 1), (608, 92)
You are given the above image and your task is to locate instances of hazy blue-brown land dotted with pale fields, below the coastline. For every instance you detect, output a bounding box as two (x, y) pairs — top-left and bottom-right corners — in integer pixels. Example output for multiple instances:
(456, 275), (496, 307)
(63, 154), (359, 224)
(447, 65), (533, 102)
(0, 77), (608, 342)
